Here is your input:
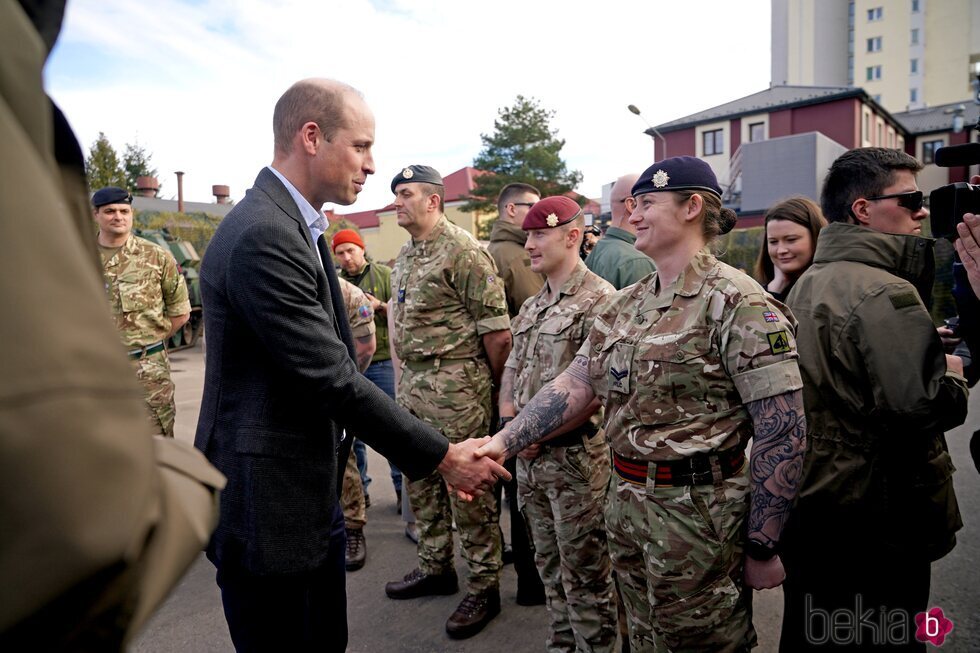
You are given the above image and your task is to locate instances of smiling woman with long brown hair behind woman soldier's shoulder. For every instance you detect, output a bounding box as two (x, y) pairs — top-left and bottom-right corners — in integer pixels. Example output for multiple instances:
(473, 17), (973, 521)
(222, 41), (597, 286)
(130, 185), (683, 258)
(755, 197), (827, 302)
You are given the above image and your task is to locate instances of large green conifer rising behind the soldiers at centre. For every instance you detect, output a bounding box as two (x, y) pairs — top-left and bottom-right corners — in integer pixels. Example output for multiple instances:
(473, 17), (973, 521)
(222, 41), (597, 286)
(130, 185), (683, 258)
(463, 95), (582, 236)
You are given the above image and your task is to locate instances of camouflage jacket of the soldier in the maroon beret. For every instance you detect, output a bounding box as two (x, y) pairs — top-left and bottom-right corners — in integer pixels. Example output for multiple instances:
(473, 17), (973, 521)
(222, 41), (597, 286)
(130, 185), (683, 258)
(507, 261), (615, 426)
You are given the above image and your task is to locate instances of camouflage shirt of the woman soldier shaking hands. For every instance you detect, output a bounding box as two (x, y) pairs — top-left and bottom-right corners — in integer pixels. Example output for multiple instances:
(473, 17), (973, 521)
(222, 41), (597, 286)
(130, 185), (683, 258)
(578, 249), (802, 461)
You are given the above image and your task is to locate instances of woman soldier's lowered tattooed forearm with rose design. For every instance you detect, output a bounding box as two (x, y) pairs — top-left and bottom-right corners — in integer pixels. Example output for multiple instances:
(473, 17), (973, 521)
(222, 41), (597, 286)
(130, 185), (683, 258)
(746, 390), (806, 544)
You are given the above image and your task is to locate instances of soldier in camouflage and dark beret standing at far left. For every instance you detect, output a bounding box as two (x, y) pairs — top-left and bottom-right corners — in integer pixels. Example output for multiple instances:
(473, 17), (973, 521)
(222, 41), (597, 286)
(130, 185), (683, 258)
(92, 186), (191, 438)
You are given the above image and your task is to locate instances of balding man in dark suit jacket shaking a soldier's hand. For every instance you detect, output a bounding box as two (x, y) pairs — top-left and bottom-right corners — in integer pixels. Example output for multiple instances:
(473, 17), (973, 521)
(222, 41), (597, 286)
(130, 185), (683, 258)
(195, 79), (509, 651)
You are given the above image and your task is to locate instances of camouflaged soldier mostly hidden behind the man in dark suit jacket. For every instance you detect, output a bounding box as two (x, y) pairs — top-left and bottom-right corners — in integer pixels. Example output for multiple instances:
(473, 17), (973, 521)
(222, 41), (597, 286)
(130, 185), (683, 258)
(337, 278), (377, 571)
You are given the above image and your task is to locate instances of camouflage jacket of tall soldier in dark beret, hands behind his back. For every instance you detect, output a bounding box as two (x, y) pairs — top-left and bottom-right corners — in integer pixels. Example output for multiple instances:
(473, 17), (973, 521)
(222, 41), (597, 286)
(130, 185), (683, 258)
(391, 216), (510, 361)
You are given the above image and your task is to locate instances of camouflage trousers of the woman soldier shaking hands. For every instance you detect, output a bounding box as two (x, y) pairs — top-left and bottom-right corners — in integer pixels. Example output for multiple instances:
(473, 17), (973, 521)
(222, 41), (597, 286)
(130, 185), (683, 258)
(606, 463), (756, 653)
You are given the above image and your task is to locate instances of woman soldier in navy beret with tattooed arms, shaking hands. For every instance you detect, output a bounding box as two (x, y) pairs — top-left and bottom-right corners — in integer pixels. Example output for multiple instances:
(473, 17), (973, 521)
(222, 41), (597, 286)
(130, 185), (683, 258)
(481, 157), (806, 652)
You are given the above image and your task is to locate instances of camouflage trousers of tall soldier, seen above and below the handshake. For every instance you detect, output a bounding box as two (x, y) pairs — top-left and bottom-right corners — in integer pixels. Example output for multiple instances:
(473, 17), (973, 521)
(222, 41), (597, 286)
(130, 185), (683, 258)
(397, 360), (503, 592)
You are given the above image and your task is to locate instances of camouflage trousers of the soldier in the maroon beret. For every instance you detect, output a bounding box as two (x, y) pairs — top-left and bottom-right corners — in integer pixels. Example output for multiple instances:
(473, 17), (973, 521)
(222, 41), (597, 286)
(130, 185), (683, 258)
(517, 432), (616, 653)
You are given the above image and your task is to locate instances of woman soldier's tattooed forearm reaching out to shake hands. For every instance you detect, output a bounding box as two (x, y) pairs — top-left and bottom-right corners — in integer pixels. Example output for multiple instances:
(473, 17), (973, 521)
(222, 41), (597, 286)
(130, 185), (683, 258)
(502, 370), (595, 457)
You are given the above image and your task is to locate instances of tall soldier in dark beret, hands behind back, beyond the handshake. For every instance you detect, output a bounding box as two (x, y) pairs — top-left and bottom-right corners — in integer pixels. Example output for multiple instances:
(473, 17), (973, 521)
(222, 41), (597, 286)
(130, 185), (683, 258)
(385, 166), (510, 638)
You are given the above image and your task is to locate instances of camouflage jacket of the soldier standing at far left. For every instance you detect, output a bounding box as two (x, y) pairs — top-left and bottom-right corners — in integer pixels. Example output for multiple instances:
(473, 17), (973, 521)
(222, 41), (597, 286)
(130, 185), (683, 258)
(100, 234), (191, 347)
